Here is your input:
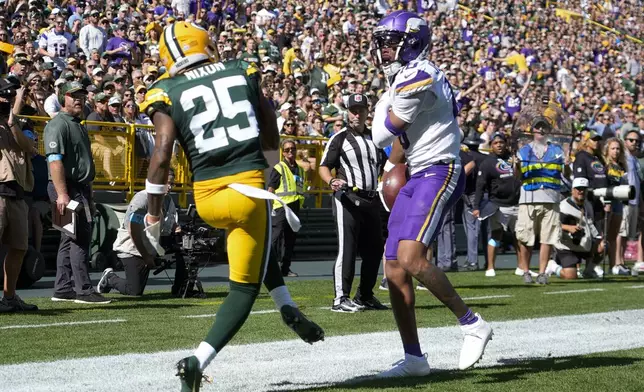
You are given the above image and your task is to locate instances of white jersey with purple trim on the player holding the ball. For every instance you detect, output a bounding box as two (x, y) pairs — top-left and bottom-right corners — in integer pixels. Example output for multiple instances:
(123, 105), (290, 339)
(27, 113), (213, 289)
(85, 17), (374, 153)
(374, 60), (461, 174)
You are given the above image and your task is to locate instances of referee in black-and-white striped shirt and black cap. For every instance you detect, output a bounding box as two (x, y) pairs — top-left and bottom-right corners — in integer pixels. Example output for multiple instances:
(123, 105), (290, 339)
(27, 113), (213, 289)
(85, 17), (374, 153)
(319, 94), (387, 313)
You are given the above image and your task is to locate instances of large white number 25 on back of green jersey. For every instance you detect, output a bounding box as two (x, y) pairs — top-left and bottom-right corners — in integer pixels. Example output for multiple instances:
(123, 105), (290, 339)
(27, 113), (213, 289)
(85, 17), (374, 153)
(181, 75), (259, 153)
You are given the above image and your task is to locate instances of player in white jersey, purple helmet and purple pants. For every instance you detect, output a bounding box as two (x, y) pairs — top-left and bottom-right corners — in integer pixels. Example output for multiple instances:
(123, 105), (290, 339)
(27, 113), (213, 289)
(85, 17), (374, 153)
(372, 11), (492, 377)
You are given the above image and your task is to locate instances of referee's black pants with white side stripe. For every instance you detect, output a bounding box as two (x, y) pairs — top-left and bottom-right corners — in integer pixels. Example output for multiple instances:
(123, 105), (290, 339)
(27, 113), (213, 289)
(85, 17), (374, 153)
(333, 192), (384, 304)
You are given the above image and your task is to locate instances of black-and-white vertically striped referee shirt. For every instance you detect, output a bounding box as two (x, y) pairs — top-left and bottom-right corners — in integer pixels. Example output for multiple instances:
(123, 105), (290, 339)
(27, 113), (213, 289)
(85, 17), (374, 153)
(320, 127), (387, 191)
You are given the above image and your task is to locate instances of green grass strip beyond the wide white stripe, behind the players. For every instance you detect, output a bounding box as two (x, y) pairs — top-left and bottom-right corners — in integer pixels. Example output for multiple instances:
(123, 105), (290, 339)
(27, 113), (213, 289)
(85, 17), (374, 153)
(0, 271), (644, 364)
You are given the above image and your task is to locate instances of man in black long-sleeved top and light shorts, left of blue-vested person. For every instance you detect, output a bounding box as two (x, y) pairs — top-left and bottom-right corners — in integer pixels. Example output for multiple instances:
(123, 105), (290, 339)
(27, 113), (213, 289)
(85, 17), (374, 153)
(471, 132), (521, 277)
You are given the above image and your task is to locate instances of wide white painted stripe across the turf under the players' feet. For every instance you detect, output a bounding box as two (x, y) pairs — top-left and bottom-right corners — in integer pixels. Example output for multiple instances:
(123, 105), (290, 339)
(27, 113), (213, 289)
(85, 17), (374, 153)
(0, 310), (644, 392)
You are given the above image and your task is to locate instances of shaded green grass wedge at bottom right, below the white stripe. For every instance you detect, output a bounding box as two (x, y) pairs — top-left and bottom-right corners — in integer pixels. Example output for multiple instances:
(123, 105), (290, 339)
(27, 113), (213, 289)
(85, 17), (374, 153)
(300, 348), (644, 392)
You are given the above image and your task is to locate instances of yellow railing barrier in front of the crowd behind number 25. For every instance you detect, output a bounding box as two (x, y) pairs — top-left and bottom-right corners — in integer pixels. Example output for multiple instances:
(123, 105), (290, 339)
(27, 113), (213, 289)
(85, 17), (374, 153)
(21, 116), (331, 208)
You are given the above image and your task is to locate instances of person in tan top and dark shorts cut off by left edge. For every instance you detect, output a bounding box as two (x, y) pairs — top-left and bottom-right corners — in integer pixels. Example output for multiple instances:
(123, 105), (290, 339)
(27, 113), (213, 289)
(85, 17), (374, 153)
(0, 79), (38, 313)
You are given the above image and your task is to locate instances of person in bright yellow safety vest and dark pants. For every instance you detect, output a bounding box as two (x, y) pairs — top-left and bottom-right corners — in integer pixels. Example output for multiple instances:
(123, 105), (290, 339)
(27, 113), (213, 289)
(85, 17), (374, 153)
(268, 139), (304, 277)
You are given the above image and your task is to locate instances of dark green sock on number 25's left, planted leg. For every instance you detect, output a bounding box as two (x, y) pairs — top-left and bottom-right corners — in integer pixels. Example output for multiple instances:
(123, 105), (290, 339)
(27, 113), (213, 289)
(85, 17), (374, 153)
(204, 282), (259, 352)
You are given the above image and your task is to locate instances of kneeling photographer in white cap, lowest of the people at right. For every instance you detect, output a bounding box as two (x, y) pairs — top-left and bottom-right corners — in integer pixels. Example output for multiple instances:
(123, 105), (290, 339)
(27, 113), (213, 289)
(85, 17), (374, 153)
(546, 177), (605, 279)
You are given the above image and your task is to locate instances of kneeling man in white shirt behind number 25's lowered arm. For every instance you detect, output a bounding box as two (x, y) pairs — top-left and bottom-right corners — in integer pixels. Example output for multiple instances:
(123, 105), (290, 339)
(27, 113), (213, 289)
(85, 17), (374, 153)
(96, 169), (185, 296)
